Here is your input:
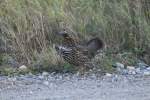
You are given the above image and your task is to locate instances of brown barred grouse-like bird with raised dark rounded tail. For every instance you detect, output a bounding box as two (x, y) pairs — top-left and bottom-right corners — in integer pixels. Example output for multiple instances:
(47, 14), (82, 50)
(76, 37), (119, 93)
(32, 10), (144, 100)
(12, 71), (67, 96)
(55, 31), (104, 68)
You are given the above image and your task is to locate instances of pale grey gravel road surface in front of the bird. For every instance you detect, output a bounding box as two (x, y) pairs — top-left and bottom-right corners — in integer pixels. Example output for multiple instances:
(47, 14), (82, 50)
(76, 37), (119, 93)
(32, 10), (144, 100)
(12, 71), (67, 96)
(0, 72), (150, 100)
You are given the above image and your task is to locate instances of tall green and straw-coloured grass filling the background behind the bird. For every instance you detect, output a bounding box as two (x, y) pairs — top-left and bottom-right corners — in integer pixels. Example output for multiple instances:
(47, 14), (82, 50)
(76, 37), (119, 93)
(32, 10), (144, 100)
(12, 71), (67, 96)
(0, 0), (150, 74)
